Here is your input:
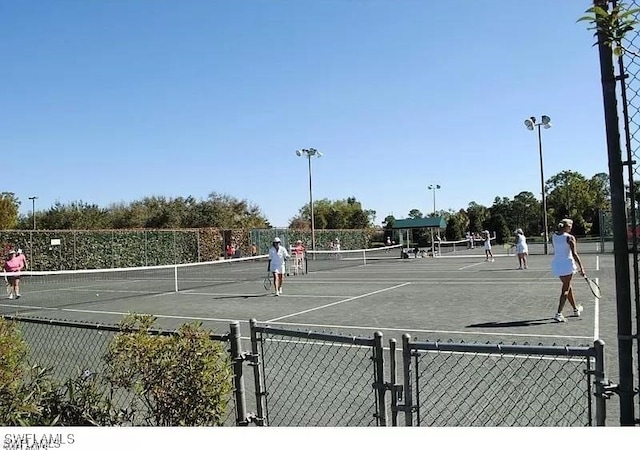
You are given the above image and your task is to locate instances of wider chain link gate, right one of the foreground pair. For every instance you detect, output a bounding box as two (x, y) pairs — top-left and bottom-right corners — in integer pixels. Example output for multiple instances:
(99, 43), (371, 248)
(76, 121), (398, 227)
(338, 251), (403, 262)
(391, 335), (606, 427)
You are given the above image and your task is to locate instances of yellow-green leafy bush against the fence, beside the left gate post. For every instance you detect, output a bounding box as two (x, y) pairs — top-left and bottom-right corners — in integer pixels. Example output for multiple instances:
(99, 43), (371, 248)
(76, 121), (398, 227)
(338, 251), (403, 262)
(105, 315), (232, 426)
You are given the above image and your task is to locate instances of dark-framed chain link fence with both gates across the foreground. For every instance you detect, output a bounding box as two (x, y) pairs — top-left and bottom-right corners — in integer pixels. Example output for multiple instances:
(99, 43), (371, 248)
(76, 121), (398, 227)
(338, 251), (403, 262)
(3, 316), (608, 426)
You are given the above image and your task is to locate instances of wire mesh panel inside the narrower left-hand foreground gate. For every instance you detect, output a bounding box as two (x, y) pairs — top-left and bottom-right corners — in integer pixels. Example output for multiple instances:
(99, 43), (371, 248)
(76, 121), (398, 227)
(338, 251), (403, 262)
(260, 330), (376, 426)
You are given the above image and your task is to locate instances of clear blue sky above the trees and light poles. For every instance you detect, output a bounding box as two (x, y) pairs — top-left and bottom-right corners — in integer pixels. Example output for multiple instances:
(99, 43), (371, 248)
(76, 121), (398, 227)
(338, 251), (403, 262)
(0, 0), (608, 226)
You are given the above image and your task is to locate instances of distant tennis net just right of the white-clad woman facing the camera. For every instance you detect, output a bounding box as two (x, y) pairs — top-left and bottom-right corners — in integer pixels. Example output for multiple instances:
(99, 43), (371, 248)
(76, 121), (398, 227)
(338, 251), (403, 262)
(305, 245), (402, 273)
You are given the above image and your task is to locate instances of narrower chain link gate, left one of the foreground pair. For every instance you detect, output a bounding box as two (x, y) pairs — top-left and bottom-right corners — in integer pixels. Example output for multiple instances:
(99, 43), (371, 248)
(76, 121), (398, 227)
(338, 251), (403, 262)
(250, 320), (387, 426)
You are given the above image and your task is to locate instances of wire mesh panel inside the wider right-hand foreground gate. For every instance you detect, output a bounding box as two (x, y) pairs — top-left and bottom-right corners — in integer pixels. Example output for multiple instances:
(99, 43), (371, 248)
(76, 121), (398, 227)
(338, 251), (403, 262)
(414, 346), (592, 427)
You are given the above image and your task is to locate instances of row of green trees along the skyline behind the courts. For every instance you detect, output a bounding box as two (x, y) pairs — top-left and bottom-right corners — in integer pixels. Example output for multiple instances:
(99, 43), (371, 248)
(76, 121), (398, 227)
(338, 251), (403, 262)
(0, 170), (620, 240)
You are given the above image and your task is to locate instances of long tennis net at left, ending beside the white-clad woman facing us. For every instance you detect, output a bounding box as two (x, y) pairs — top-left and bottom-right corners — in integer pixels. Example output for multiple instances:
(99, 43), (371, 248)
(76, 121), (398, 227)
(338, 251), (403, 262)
(0, 255), (268, 307)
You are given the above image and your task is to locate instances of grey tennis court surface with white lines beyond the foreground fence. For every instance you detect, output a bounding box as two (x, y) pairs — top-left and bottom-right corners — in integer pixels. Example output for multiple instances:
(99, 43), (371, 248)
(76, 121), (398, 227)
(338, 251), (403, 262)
(0, 249), (617, 426)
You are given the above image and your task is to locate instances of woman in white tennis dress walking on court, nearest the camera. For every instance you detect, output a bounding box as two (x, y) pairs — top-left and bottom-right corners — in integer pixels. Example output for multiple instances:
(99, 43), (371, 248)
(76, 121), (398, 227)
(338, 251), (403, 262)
(551, 219), (585, 322)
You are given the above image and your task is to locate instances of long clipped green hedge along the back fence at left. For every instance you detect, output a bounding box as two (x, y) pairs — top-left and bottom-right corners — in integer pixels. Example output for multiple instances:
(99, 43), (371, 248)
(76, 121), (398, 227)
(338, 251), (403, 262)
(0, 228), (379, 270)
